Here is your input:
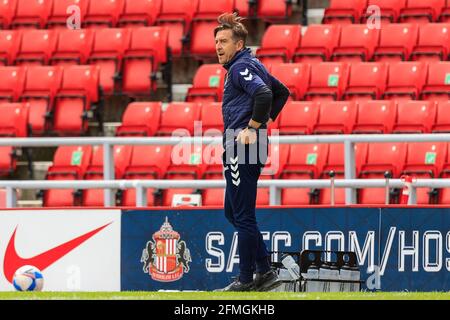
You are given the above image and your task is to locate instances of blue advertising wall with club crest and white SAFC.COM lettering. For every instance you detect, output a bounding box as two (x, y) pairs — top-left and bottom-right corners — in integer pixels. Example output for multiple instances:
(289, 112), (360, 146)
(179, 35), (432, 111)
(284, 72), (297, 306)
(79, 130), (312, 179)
(121, 206), (450, 291)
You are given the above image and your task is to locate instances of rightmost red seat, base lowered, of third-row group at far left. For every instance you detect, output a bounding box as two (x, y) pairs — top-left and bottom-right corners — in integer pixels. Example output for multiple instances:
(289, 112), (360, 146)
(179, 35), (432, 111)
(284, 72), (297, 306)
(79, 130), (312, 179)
(53, 65), (99, 134)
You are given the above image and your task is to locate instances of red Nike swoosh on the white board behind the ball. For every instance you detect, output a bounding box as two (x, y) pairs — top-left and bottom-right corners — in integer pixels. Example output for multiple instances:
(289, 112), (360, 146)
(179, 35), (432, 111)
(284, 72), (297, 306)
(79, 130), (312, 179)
(3, 222), (112, 283)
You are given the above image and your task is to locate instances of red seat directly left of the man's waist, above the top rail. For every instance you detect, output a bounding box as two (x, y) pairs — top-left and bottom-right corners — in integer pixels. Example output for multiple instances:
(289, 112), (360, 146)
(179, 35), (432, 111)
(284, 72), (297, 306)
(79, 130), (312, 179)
(200, 102), (224, 136)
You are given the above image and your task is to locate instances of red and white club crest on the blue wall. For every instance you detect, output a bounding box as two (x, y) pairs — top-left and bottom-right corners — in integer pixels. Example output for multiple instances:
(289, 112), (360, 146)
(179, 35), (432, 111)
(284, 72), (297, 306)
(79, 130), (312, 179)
(141, 217), (192, 282)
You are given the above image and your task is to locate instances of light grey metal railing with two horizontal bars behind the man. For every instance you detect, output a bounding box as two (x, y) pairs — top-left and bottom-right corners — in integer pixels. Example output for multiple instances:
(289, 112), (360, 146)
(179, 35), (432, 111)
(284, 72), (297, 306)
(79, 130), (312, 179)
(0, 134), (450, 207)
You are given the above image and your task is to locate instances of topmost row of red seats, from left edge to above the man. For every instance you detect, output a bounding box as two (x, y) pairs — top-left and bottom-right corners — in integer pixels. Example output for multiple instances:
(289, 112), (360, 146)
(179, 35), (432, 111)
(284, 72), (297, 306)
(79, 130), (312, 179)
(0, 0), (292, 55)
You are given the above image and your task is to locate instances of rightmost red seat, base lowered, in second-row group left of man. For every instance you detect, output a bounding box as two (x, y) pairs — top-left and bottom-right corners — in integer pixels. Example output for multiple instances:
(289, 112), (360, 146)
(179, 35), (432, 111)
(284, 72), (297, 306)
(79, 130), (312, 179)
(122, 27), (168, 96)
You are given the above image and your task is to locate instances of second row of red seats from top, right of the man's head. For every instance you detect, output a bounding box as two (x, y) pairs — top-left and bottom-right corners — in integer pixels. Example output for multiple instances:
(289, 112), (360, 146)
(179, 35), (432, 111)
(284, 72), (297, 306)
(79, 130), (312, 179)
(256, 23), (450, 65)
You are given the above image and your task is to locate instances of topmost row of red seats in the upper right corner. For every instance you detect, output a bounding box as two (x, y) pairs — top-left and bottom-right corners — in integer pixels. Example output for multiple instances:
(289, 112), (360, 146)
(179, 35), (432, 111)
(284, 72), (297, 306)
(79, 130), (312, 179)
(322, 0), (450, 24)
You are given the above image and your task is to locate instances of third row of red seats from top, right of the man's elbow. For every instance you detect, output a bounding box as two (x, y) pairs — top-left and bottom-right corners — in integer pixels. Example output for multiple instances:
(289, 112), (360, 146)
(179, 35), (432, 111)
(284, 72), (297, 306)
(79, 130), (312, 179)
(271, 61), (450, 101)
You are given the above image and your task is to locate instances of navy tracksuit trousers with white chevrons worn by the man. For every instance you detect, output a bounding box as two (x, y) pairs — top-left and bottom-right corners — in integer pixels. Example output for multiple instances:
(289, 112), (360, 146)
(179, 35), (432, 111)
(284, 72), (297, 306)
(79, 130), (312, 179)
(223, 136), (270, 283)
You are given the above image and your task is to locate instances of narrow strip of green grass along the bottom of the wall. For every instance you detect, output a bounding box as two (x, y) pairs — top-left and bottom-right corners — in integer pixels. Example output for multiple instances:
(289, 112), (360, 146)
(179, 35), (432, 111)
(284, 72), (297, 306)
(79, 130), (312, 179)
(0, 291), (450, 300)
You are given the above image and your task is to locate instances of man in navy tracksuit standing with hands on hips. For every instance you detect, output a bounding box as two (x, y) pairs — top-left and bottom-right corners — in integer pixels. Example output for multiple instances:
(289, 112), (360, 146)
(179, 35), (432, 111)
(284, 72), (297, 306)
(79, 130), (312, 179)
(214, 13), (289, 291)
